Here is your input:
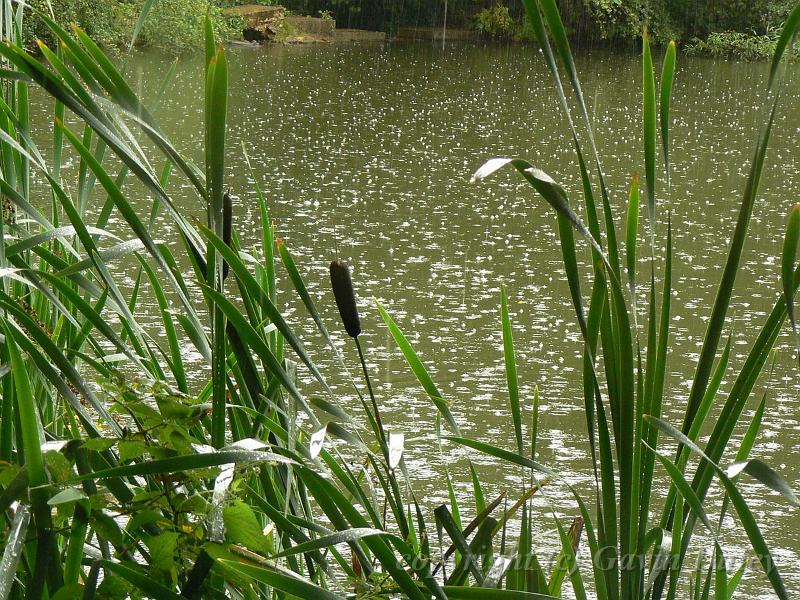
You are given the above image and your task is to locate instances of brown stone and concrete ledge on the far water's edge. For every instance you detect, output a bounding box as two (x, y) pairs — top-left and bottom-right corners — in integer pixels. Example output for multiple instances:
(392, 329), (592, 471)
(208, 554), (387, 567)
(225, 4), (386, 43)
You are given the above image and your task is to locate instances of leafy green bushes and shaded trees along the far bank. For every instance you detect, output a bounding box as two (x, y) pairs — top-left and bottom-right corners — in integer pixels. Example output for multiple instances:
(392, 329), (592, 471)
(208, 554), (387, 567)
(18, 0), (790, 54)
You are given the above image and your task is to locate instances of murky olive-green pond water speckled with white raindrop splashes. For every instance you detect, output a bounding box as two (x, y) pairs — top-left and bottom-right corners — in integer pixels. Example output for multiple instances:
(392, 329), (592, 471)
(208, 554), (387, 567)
(31, 44), (800, 598)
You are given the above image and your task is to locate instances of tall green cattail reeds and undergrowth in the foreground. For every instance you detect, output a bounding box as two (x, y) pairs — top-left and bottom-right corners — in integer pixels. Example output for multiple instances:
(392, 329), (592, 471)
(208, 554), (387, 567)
(0, 0), (800, 600)
